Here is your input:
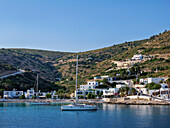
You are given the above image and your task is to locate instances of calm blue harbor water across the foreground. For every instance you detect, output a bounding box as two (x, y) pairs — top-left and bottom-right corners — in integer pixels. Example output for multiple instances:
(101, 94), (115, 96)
(0, 103), (170, 128)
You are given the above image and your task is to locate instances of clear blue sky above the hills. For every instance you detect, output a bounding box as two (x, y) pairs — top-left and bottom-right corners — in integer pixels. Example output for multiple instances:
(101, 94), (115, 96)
(0, 0), (170, 52)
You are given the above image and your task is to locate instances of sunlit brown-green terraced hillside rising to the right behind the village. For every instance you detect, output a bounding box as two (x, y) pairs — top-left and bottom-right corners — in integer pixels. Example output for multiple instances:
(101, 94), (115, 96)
(58, 31), (170, 84)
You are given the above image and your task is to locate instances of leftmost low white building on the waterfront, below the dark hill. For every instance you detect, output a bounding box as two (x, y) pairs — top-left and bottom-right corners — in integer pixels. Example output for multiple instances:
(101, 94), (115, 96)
(3, 89), (23, 98)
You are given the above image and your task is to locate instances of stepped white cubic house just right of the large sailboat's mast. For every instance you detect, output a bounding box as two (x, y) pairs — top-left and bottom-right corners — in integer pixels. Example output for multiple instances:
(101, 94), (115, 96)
(80, 81), (99, 90)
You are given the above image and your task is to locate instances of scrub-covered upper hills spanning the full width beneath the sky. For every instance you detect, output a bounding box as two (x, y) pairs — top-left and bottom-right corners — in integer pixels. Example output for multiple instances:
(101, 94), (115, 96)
(0, 31), (170, 91)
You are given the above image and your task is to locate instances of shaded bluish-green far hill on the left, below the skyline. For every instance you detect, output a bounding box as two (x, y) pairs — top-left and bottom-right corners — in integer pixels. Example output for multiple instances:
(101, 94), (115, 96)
(0, 48), (71, 80)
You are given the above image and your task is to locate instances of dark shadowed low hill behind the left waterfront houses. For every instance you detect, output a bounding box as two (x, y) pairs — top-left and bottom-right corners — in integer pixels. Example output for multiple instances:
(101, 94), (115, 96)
(0, 72), (63, 92)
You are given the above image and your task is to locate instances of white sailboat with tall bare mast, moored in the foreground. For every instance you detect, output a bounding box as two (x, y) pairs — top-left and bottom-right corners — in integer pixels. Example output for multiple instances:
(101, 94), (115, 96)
(61, 55), (98, 111)
